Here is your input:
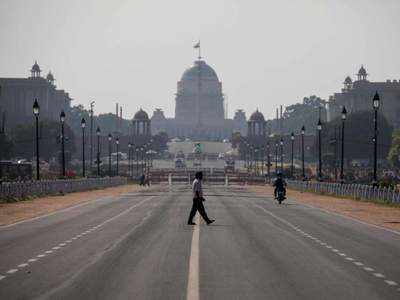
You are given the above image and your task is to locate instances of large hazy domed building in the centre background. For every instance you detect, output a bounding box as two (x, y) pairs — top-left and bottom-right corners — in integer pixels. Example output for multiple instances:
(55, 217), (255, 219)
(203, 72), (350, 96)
(151, 58), (246, 140)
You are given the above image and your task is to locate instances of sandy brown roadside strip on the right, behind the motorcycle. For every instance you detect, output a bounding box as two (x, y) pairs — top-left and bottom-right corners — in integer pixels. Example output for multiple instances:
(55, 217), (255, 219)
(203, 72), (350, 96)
(248, 186), (400, 232)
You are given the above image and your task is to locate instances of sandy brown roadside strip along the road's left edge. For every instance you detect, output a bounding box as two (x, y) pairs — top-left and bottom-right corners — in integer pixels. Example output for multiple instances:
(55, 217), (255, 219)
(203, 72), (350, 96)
(0, 184), (145, 226)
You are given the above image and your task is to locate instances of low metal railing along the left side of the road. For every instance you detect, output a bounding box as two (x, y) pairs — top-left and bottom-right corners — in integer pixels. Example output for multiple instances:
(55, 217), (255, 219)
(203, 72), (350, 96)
(0, 177), (127, 200)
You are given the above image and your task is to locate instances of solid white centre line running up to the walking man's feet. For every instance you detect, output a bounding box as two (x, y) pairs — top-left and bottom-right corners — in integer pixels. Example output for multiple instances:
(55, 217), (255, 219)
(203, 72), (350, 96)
(186, 215), (200, 300)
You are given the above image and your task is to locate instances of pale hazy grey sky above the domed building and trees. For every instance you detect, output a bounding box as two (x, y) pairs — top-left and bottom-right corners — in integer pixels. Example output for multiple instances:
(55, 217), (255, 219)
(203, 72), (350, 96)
(0, 0), (400, 118)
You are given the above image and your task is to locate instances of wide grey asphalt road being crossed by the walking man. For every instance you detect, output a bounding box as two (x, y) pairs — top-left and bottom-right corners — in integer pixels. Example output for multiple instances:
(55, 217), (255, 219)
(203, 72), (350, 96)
(0, 185), (400, 299)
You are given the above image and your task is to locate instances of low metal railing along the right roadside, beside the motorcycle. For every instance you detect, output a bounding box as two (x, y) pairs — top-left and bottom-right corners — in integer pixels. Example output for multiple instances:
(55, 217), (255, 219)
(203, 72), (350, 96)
(287, 180), (400, 203)
